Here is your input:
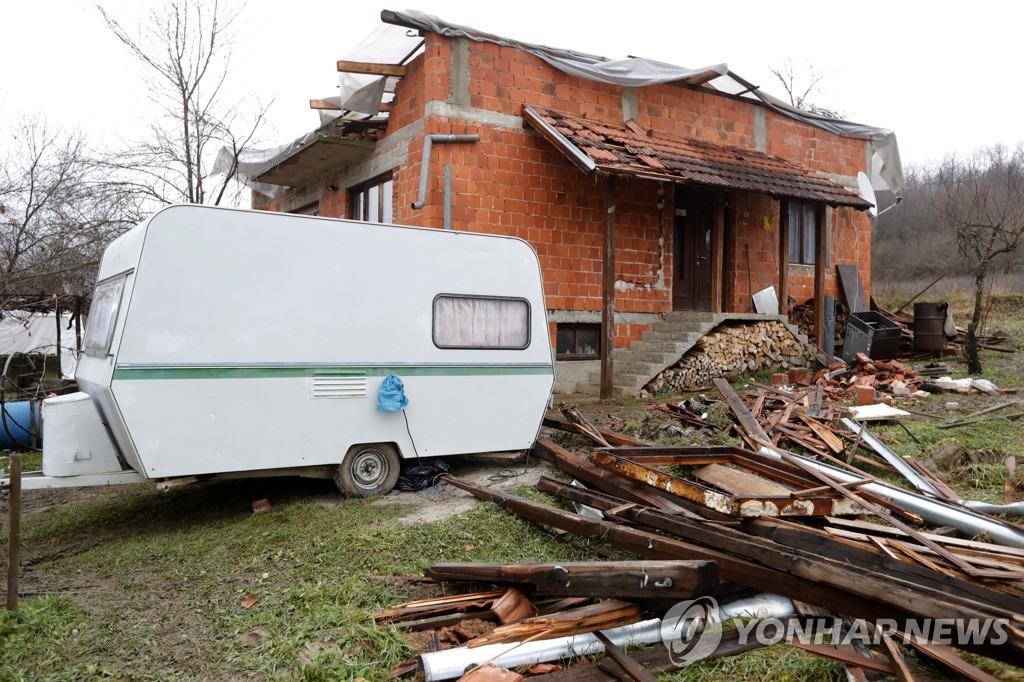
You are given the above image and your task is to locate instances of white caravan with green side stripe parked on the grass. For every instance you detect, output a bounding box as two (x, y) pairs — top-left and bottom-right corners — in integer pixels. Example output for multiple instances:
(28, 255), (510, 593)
(4, 201), (554, 497)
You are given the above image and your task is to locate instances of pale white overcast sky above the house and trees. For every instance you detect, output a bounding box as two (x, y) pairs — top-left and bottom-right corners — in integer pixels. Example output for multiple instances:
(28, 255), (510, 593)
(0, 0), (1024, 171)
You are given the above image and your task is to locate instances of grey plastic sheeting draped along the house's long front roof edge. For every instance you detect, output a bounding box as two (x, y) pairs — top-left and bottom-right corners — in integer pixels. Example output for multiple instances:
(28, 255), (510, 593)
(381, 10), (903, 194)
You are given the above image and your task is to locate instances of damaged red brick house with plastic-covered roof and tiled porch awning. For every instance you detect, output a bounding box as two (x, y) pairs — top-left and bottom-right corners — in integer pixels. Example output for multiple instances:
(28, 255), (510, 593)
(251, 10), (899, 395)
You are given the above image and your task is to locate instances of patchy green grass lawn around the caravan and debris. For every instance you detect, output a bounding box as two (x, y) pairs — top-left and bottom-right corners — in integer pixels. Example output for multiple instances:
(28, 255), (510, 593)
(0, 290), (1024, 681)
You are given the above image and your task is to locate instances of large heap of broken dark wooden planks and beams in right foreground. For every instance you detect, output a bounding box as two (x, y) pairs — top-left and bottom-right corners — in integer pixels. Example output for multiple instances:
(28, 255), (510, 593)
(378, 395), (1024, 680)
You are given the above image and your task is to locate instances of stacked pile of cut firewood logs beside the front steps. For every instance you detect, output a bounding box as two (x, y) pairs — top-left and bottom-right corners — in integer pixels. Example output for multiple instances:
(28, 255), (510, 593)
(646, 321), (813, 393)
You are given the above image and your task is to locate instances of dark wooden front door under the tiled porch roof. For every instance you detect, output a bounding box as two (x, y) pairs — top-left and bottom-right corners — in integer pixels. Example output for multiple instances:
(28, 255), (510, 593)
(672, 187), (715, 310)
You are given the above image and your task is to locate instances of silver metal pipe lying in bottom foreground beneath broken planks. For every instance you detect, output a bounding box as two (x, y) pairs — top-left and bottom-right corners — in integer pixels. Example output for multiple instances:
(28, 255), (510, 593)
(420, 593), (796, 682)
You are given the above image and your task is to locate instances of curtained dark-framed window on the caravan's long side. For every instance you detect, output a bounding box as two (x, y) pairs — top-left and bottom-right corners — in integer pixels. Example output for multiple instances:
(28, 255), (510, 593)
(433, 294), (529, 350)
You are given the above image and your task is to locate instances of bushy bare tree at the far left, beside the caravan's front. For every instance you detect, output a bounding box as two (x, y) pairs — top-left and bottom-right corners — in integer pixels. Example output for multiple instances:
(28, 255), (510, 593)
(0, 117), (139, 294)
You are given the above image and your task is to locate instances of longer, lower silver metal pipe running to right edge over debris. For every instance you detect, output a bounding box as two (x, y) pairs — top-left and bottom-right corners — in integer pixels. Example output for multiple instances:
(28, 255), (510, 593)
(760, 447), (1024, 549)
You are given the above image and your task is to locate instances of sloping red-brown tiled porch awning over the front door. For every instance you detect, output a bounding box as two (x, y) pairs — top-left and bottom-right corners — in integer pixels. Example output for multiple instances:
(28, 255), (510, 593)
(522, 106), (871, 210)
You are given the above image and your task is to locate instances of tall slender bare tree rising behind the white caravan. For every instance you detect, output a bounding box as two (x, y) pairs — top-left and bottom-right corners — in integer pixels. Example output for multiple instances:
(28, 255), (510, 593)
(96, 0), (266, 204)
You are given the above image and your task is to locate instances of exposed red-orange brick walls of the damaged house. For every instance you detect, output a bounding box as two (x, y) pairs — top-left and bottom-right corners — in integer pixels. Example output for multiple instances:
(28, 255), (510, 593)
(256, 34), (870, 345)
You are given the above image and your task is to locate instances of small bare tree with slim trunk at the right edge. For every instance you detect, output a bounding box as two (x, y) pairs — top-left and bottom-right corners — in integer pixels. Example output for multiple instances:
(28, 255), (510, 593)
(936, 144), (1024, 374)
